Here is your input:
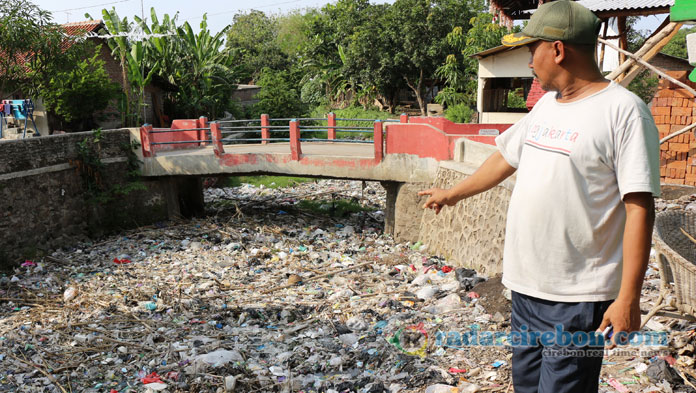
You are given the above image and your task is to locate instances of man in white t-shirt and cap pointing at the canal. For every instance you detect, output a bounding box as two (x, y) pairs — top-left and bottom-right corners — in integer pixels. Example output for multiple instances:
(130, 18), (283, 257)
(420, 0), (660, 393)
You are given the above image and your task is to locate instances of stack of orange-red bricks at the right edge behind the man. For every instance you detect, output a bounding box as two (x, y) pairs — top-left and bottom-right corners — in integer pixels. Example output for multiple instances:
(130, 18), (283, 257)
(651, 71), (696, 186)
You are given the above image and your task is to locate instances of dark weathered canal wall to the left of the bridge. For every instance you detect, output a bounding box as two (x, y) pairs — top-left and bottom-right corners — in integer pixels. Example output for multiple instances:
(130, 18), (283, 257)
(0, 129), (173, 266)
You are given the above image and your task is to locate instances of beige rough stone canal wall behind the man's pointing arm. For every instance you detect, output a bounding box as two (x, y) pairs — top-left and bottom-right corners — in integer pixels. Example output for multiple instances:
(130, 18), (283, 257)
(382, 138), (514, 275)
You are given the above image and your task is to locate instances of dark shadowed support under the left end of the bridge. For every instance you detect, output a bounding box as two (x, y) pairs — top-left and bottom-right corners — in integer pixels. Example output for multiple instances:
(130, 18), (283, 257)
(160, 176), (205, 219)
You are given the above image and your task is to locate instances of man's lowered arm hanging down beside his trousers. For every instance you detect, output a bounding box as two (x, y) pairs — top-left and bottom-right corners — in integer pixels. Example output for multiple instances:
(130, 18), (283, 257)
(599, 192), (655, 344)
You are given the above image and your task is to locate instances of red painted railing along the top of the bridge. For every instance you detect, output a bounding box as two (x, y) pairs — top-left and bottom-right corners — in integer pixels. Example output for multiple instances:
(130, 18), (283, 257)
(140, 113), (510, 164)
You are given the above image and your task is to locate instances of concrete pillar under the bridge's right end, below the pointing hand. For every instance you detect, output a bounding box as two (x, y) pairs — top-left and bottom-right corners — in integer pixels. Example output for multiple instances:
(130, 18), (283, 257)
(381, 181), (430, 243)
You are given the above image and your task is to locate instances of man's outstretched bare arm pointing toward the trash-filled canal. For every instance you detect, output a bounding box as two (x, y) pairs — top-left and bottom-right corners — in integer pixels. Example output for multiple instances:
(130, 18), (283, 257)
(418, 151), (517, 214)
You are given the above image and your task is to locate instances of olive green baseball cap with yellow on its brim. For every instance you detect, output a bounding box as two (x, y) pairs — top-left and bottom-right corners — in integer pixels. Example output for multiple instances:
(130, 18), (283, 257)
(502, 0), (602, 46)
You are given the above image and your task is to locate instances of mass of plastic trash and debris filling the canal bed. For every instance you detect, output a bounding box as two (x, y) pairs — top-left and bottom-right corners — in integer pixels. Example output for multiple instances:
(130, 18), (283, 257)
(0, 180), (696, 393)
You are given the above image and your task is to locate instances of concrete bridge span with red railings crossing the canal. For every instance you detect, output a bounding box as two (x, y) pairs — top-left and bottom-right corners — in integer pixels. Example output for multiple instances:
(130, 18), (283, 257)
(140, 114), (510, 182)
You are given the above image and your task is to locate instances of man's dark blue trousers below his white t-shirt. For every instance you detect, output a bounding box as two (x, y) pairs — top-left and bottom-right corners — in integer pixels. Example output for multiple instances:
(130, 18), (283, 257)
(511, 292), (612, 393)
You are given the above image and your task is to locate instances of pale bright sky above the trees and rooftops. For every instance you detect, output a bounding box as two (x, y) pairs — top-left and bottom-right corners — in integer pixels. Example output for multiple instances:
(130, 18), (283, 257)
(33, 0), (665, 32)
